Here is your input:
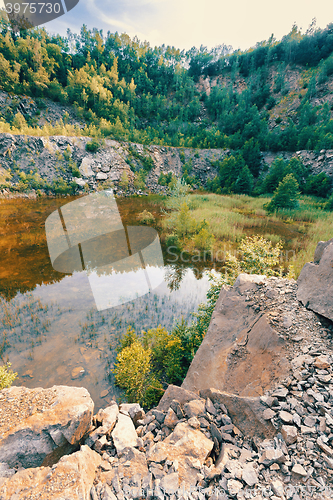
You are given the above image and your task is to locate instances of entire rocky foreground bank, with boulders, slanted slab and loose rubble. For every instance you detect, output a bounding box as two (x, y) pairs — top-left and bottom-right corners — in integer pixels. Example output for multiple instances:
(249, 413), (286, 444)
(0, 242), (333, 500)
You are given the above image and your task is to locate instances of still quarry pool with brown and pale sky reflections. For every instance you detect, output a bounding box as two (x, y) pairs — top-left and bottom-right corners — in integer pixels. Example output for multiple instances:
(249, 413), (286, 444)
(0, 195), (214, 408)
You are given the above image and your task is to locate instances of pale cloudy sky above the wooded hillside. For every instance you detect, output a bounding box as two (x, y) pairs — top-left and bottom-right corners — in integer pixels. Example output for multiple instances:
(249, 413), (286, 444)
(0, 0), (333, 50)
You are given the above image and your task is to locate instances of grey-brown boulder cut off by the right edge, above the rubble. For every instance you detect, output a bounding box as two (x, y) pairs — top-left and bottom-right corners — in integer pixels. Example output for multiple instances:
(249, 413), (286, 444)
(297, 238), (333, 321)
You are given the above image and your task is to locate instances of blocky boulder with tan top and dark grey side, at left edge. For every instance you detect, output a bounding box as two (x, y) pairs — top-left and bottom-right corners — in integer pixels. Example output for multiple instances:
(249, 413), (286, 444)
(0, 386), (94, 468)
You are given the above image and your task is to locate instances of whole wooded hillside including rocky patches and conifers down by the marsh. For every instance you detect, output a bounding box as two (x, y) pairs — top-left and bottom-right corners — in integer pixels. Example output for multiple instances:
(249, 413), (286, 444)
(0, 12), (333, 203)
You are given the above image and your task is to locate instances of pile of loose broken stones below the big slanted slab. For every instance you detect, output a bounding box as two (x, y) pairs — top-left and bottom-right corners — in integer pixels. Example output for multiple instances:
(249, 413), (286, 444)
(0, 354), (333, 500)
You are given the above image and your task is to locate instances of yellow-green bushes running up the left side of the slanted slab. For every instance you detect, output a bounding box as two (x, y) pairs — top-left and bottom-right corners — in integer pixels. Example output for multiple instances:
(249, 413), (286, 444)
(113, 236), (282, 407)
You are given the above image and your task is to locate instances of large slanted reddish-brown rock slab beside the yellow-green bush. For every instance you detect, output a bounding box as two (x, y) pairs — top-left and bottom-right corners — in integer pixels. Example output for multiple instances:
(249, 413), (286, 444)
(182, 274), (290, 397)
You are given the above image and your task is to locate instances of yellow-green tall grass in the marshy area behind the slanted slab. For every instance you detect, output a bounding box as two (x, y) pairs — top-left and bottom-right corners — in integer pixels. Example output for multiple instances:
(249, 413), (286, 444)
(162, 193), (333, 277)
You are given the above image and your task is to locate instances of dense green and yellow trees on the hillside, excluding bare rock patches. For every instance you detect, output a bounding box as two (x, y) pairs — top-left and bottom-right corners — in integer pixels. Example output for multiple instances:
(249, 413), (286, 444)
(0, 12), (333, 156)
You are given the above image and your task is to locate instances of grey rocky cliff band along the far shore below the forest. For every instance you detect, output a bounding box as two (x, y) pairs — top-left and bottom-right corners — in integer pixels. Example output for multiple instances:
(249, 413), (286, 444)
(0, 134), (333, 194)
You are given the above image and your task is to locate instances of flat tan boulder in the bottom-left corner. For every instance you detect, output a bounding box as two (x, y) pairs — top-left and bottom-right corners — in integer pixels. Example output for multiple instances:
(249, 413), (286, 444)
(0, 446), (101, 500)
